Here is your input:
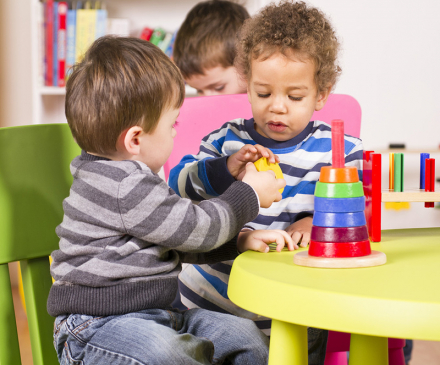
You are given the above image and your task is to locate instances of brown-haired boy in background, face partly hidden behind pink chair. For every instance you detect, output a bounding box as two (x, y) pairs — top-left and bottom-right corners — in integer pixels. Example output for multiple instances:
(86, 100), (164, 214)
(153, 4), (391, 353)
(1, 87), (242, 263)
(173, 0), (249, 96)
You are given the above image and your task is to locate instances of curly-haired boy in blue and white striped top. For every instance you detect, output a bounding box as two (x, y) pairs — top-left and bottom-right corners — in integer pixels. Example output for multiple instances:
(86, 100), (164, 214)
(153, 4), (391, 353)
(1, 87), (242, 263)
(169, 1), (363, 365)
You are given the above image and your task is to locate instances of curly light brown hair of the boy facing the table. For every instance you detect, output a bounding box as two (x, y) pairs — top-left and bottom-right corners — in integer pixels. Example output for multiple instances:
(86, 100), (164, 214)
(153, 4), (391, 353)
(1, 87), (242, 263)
(234, 0), (341, 92)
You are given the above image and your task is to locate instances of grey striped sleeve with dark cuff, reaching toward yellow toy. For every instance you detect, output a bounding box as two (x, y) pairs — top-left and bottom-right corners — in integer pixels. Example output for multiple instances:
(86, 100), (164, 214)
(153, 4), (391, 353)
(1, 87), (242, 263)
(118, 171), (259, 252)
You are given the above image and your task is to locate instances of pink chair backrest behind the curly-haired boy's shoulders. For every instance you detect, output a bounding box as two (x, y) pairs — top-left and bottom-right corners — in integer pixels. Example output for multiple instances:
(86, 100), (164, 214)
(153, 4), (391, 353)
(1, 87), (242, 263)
(164, 94), (361, 179)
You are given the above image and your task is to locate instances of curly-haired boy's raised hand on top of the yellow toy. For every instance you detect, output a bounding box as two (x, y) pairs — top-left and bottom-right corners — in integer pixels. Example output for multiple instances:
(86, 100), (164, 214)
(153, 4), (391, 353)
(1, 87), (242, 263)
(226, 144), (280, 180)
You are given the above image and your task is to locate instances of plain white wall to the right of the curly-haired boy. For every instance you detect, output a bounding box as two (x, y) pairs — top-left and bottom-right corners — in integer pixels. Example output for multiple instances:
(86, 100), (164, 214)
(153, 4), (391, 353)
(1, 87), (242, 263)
(300, 0), (440, 228)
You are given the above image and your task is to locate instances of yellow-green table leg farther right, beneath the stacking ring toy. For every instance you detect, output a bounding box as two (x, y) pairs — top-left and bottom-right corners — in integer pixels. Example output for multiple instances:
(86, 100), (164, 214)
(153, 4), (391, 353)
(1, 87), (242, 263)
(349, 333), (388, 365)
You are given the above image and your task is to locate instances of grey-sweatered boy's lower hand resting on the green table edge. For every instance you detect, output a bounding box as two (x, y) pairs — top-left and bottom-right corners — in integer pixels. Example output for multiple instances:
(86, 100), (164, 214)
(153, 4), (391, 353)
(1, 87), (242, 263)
(237, 229), (298, 253)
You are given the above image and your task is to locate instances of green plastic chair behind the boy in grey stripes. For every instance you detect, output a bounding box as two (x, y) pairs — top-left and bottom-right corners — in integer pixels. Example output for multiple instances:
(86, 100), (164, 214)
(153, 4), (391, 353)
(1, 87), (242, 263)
(0, 124), (80, 365)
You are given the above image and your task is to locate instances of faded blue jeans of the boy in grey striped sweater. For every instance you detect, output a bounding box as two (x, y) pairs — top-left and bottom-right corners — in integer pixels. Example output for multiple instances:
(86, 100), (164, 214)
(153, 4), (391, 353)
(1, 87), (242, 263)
(54, 309), (269, 365)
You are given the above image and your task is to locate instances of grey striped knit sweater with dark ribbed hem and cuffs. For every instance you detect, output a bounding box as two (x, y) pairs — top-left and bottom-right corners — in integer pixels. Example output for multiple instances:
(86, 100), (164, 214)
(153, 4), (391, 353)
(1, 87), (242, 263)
(47, 152), (259, 316)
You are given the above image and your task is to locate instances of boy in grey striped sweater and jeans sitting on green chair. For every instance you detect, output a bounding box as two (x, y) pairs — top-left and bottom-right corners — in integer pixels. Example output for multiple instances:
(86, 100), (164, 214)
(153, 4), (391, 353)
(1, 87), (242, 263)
(47, 36), (293, 365)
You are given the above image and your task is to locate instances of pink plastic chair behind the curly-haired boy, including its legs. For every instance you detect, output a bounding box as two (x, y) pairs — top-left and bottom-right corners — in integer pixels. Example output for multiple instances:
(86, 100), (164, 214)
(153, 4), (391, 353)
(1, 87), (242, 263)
(164, 94), (405, 365)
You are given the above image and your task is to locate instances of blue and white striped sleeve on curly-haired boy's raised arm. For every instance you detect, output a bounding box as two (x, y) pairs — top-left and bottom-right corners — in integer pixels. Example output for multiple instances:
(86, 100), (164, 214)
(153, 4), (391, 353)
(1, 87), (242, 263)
(168, 124), (235, 201)
